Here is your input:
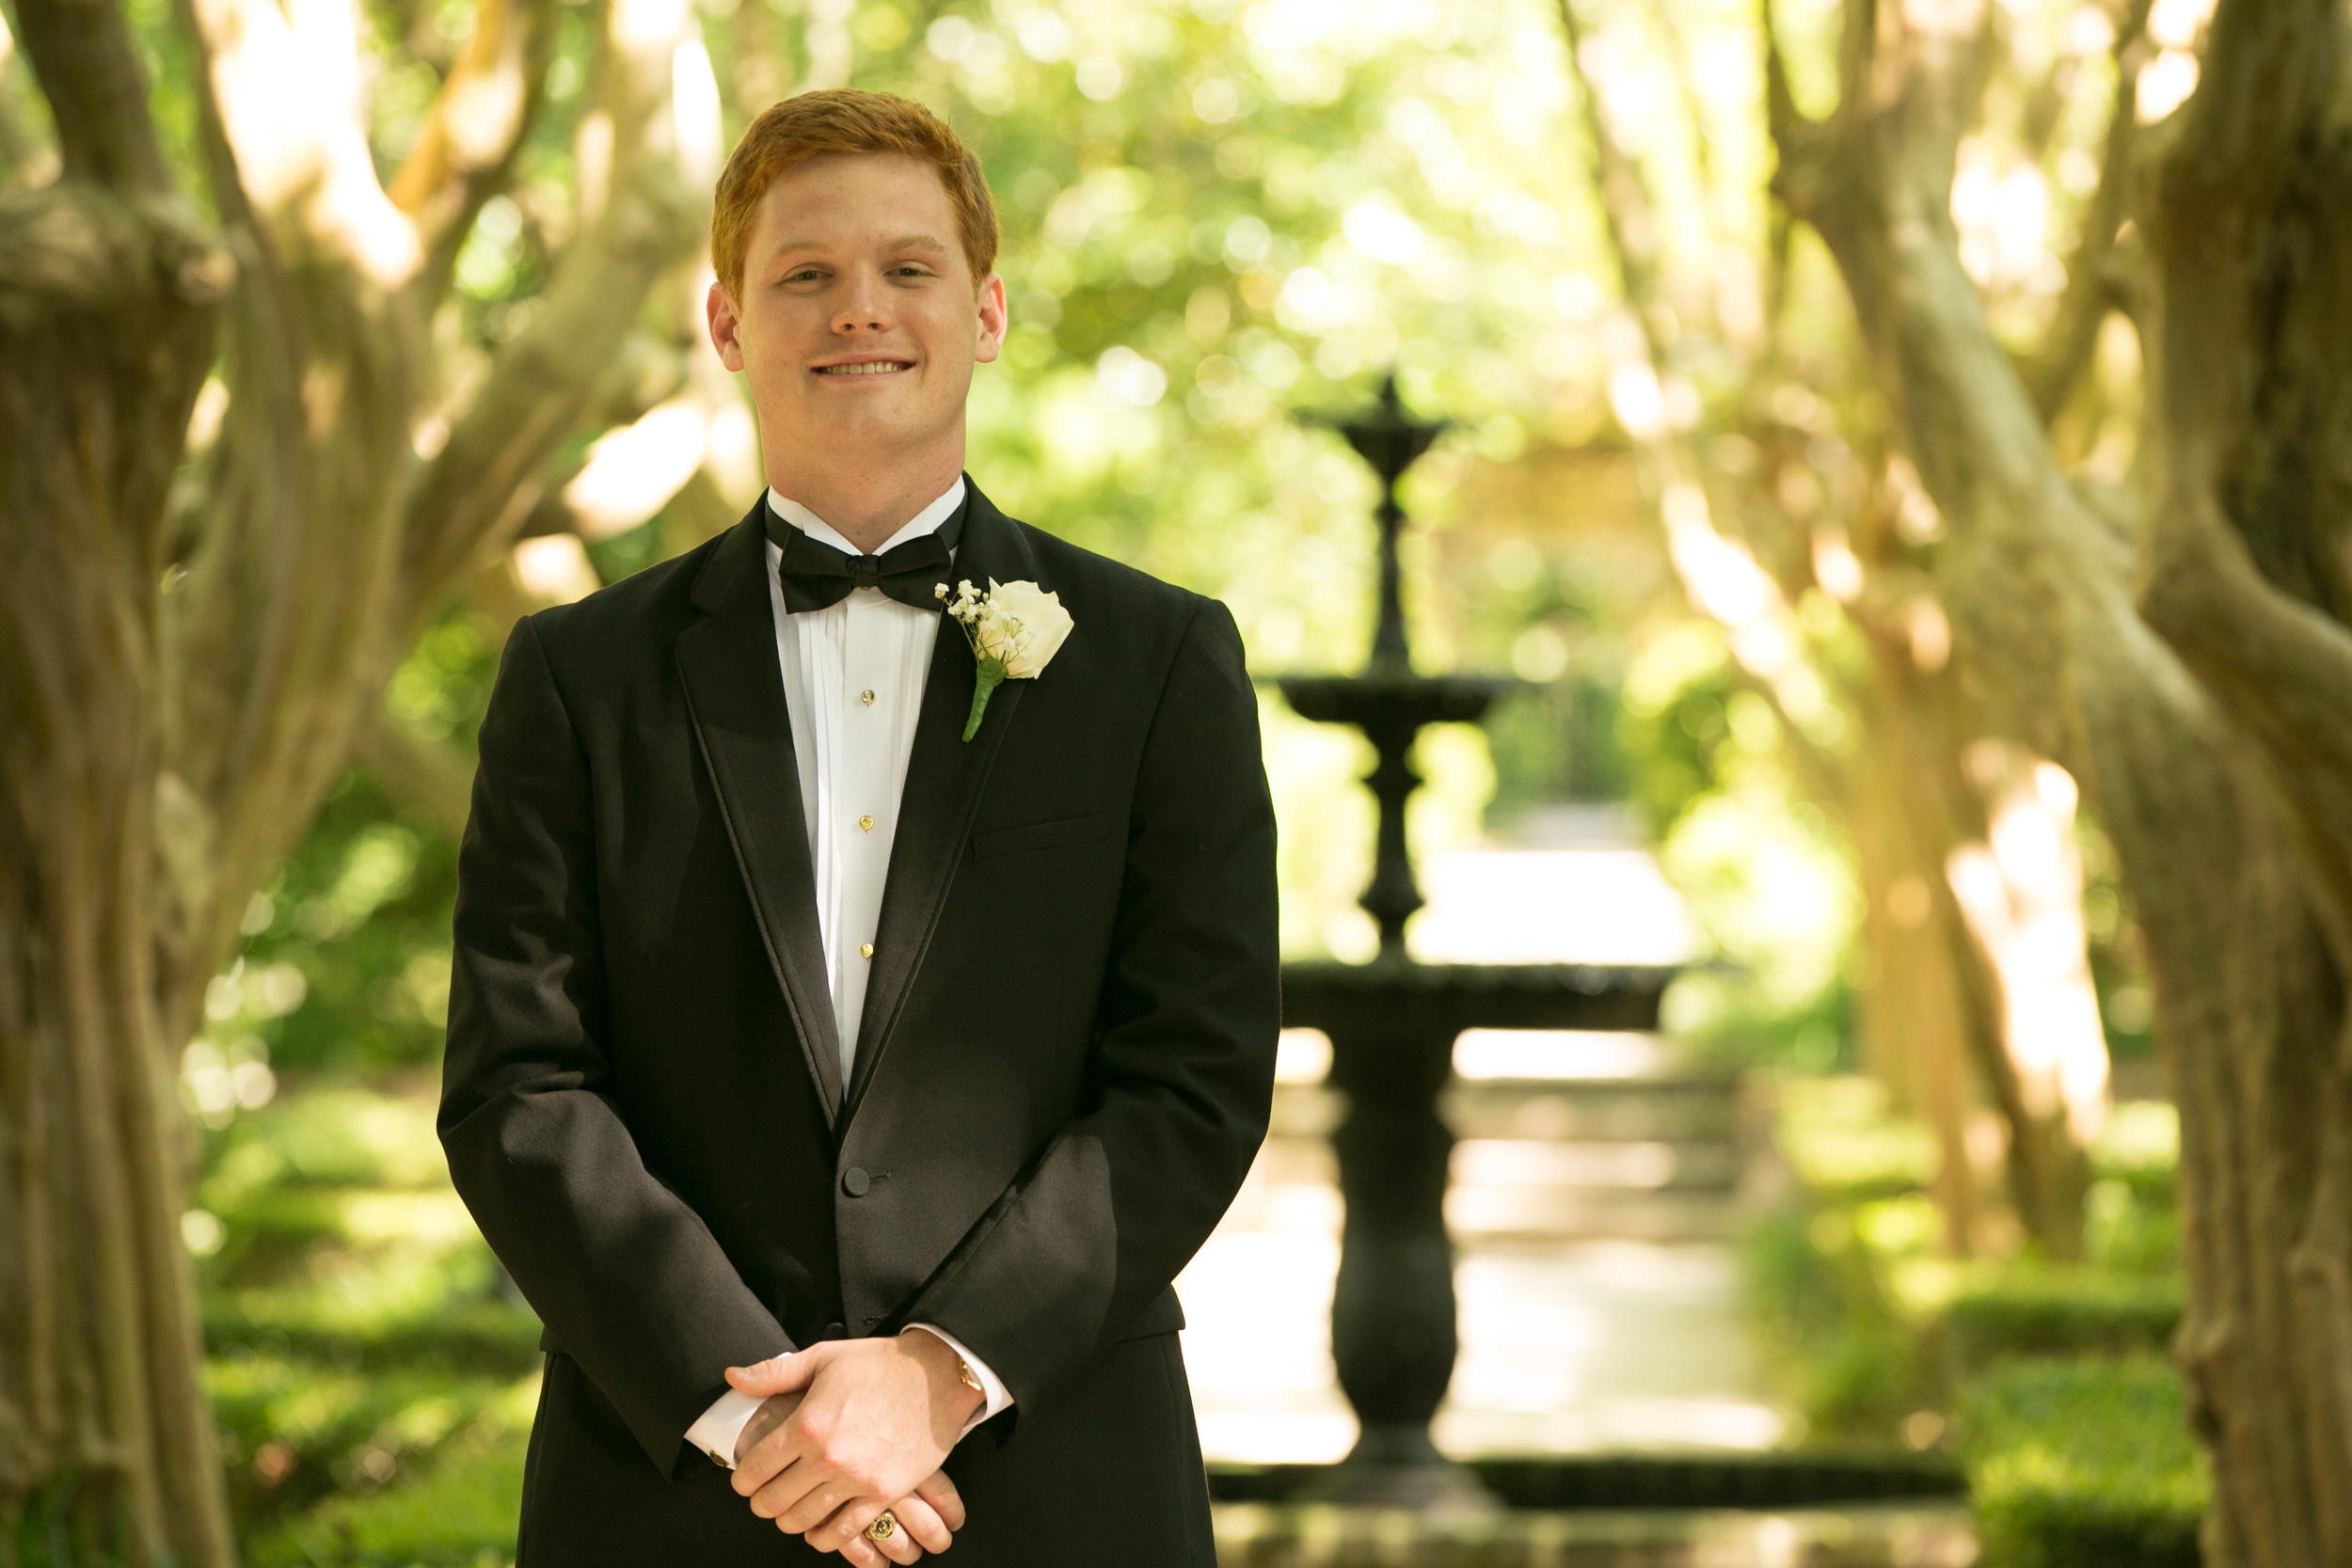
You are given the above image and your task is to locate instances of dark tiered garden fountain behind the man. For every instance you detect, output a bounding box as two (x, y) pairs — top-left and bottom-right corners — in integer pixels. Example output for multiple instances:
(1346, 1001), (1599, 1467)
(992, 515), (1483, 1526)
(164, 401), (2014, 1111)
(1275, 376), (1675, 1510)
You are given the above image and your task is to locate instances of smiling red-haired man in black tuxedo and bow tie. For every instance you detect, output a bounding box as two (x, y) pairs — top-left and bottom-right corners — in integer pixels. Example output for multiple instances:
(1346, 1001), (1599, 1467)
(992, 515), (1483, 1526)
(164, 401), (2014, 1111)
(440, 91), (1278, 1568)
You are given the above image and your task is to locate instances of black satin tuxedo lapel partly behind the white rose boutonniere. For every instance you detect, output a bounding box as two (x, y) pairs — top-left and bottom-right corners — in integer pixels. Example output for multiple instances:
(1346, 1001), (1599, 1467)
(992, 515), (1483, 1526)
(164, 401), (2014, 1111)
(842, 475), (1038, 1119)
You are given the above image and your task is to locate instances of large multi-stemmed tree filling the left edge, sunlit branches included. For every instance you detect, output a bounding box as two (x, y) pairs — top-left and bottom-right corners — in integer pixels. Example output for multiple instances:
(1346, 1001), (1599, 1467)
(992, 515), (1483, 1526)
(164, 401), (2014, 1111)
(0, 0), (718, 1568)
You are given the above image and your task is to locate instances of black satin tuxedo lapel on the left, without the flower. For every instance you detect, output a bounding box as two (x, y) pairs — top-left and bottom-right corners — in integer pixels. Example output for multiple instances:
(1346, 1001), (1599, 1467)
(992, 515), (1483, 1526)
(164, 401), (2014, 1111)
(677, 500), (842, 1121)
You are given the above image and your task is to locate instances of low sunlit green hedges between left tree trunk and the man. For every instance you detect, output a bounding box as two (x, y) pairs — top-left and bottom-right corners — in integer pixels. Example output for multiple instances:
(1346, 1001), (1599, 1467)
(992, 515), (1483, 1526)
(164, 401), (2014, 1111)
(188, 1082), (539, 1563)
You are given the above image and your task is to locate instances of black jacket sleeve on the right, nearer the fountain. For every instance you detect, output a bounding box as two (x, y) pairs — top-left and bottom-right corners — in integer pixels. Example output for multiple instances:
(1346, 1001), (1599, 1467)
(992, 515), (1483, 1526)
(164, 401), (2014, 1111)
(906, 599), (1282, 1420)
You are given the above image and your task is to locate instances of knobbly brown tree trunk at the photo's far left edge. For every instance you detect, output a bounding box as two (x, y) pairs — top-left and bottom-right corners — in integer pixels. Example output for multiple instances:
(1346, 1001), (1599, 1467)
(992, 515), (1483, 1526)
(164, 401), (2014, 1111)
(0, 183), (230, 1568)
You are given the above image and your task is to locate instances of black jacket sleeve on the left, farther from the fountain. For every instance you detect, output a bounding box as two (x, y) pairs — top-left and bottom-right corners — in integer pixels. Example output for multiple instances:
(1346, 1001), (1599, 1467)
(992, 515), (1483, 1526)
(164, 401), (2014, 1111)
(440, 618), (793, 1477)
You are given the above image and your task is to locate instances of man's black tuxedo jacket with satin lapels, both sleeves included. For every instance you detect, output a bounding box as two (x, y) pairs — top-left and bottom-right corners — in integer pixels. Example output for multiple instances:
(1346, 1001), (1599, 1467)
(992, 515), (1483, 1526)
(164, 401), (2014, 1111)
(440, 489), (1279, 1568)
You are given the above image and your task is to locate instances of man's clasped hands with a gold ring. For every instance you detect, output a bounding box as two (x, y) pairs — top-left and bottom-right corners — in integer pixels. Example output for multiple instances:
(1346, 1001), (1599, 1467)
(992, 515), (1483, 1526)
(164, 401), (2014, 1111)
(727, 1328), (981, 1568)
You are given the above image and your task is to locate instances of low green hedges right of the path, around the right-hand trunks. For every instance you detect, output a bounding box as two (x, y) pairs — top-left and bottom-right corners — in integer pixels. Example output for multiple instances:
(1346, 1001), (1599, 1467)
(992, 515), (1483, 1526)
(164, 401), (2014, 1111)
(1745, 1062), (2211, 1568)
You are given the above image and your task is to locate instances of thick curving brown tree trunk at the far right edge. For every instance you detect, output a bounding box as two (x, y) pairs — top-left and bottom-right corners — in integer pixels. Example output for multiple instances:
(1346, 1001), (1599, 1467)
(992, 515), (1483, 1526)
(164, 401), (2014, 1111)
(2140, 0), (2352, 1568)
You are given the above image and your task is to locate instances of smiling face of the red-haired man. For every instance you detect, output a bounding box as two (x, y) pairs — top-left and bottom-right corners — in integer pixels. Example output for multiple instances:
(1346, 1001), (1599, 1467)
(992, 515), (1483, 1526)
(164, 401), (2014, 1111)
(708, 152), (1005, 482)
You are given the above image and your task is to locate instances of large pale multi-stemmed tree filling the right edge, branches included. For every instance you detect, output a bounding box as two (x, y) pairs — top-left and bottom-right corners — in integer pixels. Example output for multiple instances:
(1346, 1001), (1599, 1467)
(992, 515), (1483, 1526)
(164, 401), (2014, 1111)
(1767, 0), (2352, 1568)
